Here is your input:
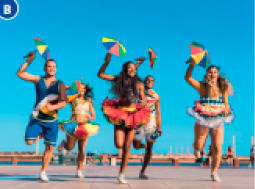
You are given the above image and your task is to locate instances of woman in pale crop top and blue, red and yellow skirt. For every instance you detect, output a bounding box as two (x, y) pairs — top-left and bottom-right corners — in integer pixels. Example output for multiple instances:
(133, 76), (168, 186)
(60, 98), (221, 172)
(58, 77), (99, 178)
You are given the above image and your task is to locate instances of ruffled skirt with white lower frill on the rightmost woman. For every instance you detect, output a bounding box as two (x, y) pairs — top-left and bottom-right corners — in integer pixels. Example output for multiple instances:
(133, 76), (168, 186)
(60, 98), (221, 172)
(187, 101), (234, 129)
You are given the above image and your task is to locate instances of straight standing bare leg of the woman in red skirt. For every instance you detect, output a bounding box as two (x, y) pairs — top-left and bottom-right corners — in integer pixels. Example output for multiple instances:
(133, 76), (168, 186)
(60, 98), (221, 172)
(120, 128), (136, 174)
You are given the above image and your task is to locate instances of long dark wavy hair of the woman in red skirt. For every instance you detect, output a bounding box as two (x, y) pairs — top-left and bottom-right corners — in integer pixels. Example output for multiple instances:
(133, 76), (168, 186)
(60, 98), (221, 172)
(111, 61), (141, 100)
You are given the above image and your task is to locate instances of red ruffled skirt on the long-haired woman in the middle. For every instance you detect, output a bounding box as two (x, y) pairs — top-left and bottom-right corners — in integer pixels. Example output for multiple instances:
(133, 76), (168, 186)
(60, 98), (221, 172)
(102, 98), (151, 128)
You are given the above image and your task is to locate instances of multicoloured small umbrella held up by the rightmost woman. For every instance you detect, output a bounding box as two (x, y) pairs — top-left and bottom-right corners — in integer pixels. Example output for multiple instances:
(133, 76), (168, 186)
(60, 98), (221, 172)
(189, 42), (210, 68)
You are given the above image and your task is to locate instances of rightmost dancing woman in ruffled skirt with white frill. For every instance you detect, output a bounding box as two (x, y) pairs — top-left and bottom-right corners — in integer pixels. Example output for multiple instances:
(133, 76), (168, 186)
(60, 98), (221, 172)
(186, 58), (234, 181)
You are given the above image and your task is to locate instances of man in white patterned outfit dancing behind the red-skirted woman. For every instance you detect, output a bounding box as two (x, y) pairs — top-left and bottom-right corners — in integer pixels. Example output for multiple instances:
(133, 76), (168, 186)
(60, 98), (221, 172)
(133, 75), (161, 179)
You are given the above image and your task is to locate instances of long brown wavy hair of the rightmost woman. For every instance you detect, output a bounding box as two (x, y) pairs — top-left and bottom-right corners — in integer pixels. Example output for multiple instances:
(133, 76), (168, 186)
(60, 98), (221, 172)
(204, 65), (234, 95)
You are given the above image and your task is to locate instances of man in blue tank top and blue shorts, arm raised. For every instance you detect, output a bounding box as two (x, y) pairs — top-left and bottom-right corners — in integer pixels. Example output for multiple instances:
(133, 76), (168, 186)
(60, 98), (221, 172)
(17, 51), (67, 182)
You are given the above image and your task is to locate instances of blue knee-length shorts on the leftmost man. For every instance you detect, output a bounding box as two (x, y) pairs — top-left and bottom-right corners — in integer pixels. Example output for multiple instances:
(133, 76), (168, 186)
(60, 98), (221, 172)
(25, 117), (58, 146)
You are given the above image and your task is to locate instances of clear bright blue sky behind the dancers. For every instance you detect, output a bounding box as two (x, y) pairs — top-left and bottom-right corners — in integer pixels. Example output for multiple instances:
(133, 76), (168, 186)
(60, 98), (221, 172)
(0, 0), (254, 155)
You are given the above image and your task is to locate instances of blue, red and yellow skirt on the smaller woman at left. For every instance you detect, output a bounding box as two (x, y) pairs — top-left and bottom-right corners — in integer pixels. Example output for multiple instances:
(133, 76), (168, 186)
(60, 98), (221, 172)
(58, 120), (99, 139)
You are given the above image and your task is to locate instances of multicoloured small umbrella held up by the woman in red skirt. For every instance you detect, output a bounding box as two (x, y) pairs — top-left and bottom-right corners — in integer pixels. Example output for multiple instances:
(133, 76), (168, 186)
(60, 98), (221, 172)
(102, 37), (126, 57)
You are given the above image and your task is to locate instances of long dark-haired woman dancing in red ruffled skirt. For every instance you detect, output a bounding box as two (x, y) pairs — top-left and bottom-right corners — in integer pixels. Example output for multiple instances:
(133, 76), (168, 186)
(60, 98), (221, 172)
(98, 53), (150, 184)
